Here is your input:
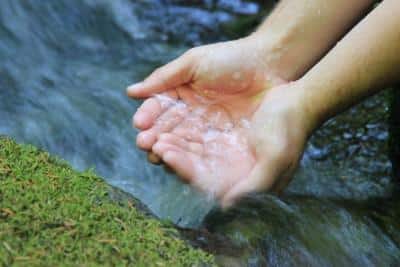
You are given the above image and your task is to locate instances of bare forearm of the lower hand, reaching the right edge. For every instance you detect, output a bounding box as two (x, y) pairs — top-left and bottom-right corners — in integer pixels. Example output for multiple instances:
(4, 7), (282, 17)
(298, 0), (400, 132)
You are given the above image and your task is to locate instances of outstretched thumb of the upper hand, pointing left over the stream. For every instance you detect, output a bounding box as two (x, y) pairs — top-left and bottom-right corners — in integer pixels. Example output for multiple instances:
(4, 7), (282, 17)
(127, 53), (193, 98)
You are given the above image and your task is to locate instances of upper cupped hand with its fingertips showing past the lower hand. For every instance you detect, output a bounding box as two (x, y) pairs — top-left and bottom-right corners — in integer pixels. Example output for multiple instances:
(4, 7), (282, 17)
(127, 38), (285, 154)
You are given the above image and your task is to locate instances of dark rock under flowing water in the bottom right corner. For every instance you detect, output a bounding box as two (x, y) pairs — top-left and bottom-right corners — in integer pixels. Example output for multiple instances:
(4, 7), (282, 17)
(186, 195), (400, 267)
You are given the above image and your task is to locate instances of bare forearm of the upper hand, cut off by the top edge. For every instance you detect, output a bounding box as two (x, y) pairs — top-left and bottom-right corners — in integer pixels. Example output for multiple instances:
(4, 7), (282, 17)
(249, 0), (373, 81)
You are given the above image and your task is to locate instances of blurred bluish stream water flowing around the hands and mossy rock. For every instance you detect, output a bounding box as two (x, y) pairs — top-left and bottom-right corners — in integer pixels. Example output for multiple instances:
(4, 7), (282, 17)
(0, 0), (400, 266)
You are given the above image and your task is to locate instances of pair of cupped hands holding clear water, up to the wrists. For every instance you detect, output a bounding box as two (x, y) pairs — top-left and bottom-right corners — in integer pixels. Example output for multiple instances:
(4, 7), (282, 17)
(128, 36), (314, 206)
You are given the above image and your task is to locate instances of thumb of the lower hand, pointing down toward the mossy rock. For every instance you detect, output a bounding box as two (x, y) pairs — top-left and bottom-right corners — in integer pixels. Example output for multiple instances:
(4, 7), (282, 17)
(221, 163), (277, 210)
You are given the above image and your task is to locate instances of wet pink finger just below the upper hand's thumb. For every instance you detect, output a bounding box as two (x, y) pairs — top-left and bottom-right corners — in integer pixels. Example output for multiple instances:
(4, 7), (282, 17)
(133, 90), (178, 130)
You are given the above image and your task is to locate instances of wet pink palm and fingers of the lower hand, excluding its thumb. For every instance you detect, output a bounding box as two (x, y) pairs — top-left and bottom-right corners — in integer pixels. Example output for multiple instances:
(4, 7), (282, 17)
(152, 92), (255, 198)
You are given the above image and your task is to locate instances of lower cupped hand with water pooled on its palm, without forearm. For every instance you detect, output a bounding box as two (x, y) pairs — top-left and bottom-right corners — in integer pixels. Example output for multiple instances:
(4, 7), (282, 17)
(147, 83), (314, 207)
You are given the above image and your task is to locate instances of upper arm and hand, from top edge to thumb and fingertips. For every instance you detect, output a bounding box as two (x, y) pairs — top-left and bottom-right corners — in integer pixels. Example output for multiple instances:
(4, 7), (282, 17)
(127, 0), (372, 151)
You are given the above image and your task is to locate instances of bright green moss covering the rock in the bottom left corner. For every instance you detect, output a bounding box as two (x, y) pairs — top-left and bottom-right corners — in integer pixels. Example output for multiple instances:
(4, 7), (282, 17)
(0, 138), (213, 266)
